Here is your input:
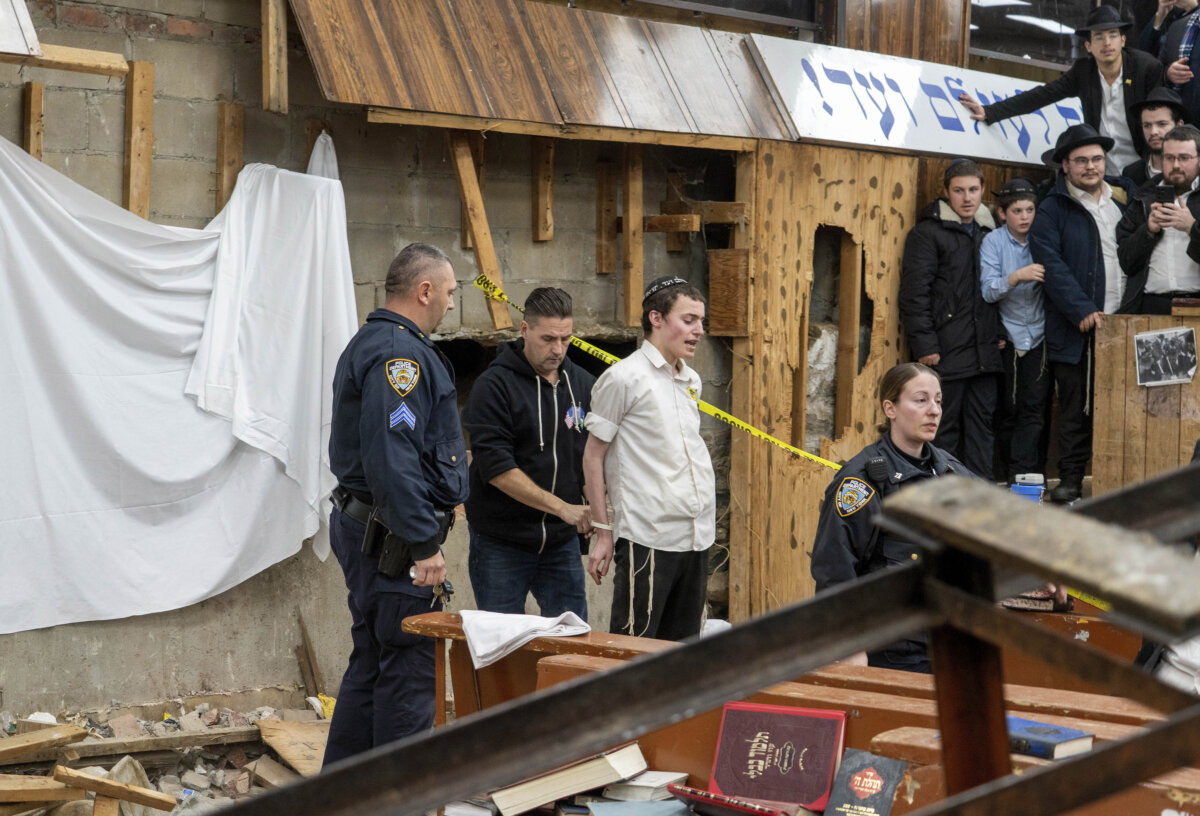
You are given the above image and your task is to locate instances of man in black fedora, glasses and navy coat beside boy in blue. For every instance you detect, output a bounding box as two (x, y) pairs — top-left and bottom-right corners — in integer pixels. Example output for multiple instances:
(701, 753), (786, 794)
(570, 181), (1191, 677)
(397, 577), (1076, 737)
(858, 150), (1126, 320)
(1030, 125), (1132, 502)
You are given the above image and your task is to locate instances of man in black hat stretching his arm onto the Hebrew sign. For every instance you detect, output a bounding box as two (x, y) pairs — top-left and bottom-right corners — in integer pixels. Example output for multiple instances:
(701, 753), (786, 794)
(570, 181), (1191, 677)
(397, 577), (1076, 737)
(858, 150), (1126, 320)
(959, 6), (1163, 170)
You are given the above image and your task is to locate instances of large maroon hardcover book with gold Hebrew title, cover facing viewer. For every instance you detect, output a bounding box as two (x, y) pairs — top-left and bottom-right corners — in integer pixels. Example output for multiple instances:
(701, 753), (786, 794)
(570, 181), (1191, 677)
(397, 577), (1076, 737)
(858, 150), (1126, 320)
(708, 703), (846, 810)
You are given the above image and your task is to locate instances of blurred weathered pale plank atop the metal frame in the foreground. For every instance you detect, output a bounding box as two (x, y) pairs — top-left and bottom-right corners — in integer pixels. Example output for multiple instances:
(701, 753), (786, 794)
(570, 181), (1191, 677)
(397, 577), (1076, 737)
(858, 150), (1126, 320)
(881, 476), (1200, 641)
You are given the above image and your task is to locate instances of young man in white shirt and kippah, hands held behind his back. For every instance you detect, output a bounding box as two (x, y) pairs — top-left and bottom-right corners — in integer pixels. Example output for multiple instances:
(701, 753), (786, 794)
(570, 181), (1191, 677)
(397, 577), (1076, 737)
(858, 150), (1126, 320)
(583, 277), (716, 641)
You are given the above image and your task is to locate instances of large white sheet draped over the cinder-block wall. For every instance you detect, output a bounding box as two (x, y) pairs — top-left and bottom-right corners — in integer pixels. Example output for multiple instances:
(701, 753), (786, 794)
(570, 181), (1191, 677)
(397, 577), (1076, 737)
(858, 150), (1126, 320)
(0, 139), (356, 632)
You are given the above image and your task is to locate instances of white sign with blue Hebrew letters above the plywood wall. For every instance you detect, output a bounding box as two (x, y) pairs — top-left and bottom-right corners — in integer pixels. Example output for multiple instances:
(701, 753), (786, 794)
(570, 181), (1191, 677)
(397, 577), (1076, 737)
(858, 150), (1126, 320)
(750, 35), (1084, 164)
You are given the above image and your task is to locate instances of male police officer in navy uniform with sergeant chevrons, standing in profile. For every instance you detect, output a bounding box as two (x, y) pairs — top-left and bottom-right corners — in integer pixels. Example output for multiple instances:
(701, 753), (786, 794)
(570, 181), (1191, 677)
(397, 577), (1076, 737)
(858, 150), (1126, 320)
(324, 244), (468, 766)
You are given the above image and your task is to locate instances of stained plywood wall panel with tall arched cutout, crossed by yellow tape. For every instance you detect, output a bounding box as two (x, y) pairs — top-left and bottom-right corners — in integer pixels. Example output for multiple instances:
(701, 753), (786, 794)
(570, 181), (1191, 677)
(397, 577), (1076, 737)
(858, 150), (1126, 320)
(730, 142), (917, 619)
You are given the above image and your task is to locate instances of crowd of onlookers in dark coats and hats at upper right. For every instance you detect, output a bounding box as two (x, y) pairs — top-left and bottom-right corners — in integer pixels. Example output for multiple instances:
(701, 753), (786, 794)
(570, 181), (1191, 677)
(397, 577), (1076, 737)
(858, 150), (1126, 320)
(900, 0), (1200, 502)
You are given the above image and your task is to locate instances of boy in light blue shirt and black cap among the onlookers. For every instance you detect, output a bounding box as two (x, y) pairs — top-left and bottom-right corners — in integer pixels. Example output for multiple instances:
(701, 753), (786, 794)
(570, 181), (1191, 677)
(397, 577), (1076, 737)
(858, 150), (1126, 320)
(979, 179), (1054, 482)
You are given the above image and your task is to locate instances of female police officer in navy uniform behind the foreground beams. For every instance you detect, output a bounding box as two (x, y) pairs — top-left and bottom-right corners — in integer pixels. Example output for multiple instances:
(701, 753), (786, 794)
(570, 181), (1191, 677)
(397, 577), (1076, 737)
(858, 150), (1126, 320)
(812, 362), (972, 672)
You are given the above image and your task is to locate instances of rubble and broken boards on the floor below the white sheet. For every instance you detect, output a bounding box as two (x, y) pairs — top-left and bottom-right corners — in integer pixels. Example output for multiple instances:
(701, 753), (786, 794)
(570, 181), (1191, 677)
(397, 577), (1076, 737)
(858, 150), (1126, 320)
(0, 703), (319, 816)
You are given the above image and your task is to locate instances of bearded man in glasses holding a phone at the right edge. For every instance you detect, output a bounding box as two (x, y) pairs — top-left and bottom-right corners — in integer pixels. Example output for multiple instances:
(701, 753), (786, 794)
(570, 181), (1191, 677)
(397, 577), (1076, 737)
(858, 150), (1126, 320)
(1117, 125), (1200, 314)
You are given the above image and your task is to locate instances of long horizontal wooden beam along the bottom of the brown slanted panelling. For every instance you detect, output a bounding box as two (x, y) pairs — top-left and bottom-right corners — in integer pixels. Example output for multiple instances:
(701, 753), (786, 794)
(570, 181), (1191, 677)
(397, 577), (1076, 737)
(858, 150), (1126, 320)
(367, 108), (753, 152)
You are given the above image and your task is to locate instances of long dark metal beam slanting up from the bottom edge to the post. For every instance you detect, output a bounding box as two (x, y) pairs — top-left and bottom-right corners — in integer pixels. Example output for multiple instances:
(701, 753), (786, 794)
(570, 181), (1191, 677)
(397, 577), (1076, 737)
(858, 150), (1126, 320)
(227, 562), (944, 816)
